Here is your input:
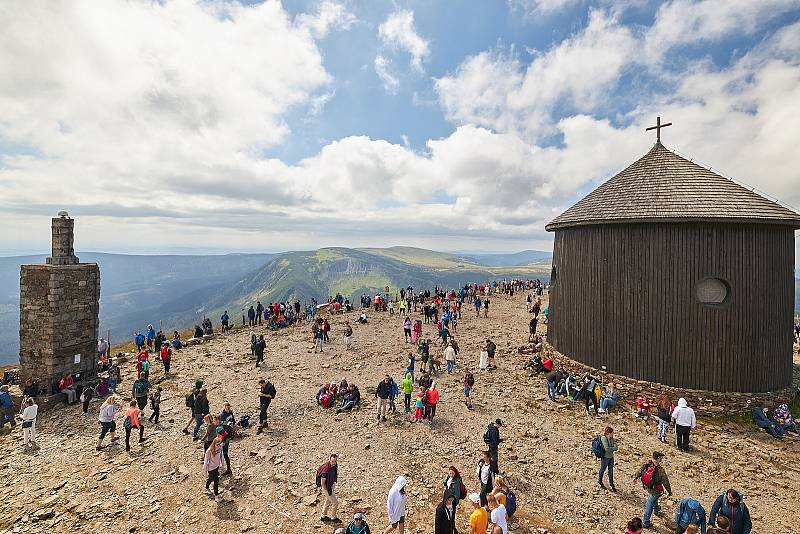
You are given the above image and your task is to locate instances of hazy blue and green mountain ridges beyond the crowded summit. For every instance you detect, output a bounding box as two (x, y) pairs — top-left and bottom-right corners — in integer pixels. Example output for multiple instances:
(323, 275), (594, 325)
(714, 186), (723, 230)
(0, 247), (550, 364)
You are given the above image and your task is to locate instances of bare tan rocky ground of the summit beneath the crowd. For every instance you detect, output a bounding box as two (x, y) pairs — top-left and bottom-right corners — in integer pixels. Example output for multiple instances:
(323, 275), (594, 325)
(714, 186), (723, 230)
(0, 296), (800, 534)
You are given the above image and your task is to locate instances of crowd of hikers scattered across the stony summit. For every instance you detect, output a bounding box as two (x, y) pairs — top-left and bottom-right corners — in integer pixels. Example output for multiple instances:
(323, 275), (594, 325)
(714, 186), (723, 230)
(0, 281), (784, 534)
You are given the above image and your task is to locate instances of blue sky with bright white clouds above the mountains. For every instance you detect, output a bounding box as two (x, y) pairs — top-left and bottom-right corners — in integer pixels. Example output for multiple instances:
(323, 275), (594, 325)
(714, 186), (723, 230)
(0, 0), (800, 255)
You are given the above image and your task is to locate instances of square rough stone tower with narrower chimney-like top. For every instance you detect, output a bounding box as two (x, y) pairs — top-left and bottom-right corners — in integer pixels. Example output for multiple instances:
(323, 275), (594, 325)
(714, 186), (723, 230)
(19, 211), (100, 392)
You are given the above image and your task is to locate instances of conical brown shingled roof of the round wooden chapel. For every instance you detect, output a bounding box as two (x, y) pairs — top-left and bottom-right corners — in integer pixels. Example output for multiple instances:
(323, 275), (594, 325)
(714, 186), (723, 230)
(545, 142), (800, 231)
